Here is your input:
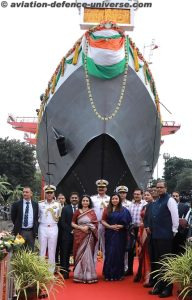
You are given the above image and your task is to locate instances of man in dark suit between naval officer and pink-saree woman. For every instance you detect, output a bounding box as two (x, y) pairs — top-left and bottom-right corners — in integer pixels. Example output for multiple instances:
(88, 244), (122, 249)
(59, 192), (79, 279)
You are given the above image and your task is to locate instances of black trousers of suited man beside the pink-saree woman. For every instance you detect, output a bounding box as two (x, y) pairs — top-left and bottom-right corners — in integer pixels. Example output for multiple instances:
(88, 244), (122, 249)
(60, 234), (73, 272)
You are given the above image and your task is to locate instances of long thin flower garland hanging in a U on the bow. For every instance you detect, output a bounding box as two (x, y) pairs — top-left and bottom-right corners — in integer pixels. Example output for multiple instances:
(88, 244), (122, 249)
(84, 31), (129, 121)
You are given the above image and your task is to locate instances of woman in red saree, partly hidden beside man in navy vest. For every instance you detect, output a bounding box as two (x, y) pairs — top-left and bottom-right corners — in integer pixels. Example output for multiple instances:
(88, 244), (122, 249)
(134, 191), (153, 287)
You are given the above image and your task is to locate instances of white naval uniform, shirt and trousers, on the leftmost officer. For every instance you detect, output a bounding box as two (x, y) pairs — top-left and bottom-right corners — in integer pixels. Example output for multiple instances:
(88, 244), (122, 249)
(38, 200), (60, 272)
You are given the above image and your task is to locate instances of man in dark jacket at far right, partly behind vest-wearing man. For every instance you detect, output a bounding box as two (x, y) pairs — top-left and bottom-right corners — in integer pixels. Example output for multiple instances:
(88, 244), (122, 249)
(172, 192), (189, 254)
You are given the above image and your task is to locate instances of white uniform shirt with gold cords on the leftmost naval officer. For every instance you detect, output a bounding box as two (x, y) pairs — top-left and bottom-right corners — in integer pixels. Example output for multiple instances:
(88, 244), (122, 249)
(39, 200), (60, 225)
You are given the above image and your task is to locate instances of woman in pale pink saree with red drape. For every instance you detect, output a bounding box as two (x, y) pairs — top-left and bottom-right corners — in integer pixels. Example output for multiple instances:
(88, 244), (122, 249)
(71, 195), (98, 283)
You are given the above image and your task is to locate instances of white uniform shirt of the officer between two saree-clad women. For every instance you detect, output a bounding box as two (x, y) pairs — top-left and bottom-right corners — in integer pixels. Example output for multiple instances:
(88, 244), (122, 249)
(91, 194), (110, 222)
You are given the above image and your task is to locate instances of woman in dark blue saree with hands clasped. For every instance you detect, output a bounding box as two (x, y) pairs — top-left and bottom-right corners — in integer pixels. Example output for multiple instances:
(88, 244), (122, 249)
(101, 194), (131, 281)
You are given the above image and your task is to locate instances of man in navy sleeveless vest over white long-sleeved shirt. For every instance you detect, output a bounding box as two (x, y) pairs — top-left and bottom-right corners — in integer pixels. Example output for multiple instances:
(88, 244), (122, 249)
(149, 181), (179, 298)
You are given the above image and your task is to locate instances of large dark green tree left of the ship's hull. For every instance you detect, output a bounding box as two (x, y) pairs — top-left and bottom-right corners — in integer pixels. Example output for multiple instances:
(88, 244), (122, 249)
(0, 138), (36, 189)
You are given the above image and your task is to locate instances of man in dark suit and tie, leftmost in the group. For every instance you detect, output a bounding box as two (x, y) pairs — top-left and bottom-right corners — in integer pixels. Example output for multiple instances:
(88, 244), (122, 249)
(11, 187), (38, 251)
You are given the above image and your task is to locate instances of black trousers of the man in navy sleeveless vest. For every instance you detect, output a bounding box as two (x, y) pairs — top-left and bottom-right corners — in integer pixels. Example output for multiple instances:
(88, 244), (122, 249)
(152, 239), (173, 292)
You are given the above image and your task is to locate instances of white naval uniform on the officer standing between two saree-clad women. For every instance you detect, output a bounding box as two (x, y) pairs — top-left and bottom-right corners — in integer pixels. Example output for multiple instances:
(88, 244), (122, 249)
(91, 194), (110, 263)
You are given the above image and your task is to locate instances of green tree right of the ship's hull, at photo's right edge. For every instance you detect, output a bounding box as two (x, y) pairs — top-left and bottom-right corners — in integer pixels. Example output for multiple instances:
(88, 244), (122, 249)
(164, 157), (192, 192)
